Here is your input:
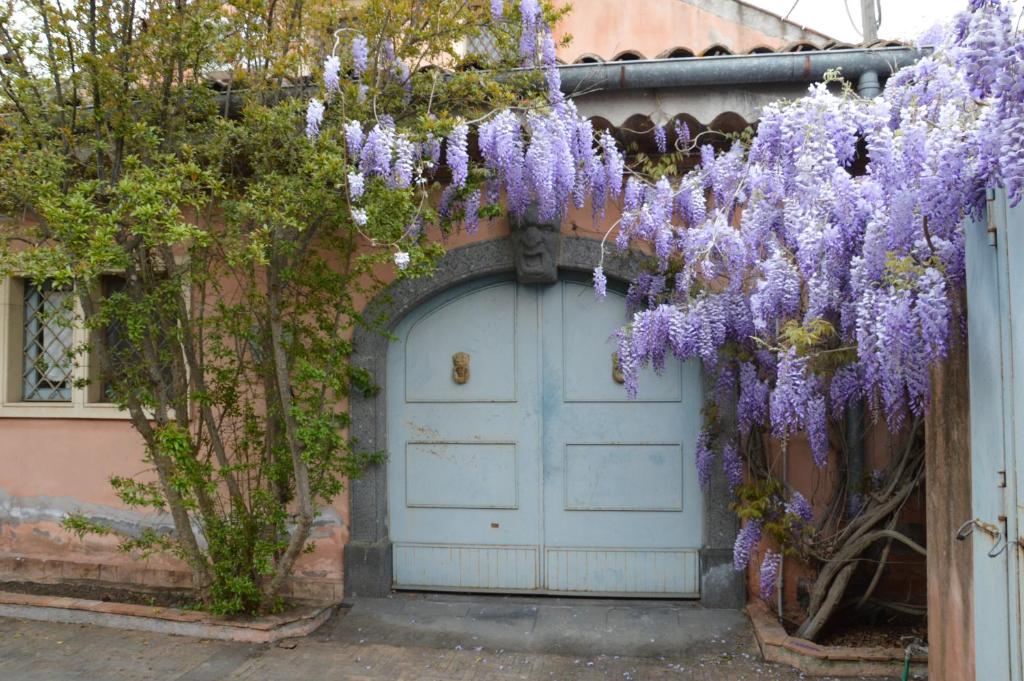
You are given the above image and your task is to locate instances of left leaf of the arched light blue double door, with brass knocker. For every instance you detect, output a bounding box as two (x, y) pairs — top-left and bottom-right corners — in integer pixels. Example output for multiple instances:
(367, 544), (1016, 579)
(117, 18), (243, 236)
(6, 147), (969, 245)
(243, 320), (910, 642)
(387, 282), (541, 591)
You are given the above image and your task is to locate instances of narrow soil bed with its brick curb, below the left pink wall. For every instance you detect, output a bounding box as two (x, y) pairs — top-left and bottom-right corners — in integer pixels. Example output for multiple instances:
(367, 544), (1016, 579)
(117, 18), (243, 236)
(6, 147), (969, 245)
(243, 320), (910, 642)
(0, 583), (334, 643)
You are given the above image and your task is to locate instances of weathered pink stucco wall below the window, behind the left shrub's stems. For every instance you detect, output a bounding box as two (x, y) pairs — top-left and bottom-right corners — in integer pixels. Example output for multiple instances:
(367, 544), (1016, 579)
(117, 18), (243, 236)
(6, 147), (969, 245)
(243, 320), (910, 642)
(0, 418), (348, 599)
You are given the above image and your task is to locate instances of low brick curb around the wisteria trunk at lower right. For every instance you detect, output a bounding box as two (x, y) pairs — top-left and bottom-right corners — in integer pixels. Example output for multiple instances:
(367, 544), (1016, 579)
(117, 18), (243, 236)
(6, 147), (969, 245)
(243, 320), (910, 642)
(746, 601), (928, 677)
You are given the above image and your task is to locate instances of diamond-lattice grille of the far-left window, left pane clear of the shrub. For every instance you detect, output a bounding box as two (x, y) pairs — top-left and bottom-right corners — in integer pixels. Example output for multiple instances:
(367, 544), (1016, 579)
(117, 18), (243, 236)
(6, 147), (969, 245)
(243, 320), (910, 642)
(22, 282), (74, 402)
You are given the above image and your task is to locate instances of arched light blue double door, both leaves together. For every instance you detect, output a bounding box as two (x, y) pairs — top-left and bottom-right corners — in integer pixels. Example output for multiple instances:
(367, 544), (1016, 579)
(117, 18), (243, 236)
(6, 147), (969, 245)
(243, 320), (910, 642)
(387, 281), (702, 597)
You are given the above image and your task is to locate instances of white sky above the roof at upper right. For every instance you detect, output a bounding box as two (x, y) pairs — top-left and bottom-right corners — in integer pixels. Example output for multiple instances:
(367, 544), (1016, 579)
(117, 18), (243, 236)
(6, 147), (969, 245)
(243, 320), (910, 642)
(745, 0), (1024, 43)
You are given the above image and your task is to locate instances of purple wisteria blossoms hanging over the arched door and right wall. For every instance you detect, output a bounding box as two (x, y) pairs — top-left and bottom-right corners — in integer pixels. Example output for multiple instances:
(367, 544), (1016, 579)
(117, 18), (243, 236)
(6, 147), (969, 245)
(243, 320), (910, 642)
(306, 0), (1024, 592)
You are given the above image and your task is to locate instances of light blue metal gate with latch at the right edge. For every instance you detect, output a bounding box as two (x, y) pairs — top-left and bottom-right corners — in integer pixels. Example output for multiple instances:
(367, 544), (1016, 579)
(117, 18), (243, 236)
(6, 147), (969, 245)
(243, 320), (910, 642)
(967, 188), (1024, 681)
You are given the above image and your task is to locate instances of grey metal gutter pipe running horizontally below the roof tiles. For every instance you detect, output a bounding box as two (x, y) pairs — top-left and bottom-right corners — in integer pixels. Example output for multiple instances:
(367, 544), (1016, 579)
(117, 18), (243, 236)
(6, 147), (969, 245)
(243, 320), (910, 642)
(558, 47), (932, 96)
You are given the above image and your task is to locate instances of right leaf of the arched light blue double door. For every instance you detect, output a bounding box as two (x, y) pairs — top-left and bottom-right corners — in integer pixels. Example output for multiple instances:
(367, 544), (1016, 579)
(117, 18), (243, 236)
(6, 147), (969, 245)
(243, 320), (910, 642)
(542, 282), (703, 597)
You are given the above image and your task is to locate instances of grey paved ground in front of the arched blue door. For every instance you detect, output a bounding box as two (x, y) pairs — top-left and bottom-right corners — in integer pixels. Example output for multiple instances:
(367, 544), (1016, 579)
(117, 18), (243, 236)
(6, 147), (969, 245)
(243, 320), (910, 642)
(0, 595), (905, 681)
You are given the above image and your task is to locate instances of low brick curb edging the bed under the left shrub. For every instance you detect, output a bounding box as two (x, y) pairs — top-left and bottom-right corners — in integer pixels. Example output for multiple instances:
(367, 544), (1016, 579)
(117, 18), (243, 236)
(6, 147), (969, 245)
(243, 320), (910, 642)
(0, 591), (334, 643)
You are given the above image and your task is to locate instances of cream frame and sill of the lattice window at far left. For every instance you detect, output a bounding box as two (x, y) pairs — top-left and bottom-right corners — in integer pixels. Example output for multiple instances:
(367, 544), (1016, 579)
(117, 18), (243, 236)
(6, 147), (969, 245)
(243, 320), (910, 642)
(0, 275), (131, 421)
